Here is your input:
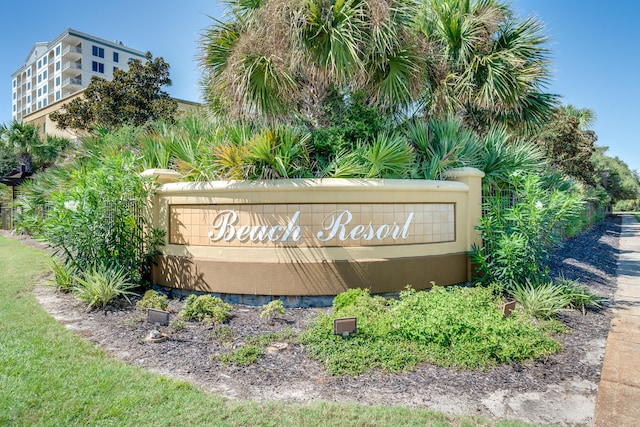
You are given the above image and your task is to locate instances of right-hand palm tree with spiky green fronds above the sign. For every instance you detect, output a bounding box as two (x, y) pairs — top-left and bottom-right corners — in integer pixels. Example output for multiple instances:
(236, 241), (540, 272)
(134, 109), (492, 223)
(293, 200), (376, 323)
(418, 0), (556, 129)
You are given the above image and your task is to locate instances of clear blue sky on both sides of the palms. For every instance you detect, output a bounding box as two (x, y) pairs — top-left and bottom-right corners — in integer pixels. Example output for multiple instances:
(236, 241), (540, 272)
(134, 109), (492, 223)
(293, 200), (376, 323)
(0, 0), (640, 170)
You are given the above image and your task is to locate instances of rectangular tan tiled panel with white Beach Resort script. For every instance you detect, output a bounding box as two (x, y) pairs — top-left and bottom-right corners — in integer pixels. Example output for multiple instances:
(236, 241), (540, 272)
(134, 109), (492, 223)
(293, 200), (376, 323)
(169, 203), (455, 247)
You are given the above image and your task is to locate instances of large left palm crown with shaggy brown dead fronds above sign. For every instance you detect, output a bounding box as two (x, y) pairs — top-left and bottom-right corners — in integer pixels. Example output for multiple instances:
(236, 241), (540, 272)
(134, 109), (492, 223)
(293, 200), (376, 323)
(201, 0), (427, 127)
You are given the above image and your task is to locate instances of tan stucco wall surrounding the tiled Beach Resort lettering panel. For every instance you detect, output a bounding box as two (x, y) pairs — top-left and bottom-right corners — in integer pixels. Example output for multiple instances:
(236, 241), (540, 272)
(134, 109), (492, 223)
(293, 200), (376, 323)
(153, 169), (483, 296)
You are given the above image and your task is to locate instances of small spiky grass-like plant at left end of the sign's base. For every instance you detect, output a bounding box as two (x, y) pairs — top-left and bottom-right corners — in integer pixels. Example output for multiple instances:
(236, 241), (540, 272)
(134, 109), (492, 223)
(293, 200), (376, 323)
(73, 266), (136, 308)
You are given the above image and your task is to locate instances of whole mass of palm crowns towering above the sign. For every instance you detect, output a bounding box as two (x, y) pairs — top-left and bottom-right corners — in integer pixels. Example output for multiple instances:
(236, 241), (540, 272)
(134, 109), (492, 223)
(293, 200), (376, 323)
(200, 0), (555, 129)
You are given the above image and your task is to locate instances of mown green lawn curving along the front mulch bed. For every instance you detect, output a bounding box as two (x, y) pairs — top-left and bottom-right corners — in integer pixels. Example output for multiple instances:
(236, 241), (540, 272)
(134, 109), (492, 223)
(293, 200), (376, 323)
(0, 237), (540, 426)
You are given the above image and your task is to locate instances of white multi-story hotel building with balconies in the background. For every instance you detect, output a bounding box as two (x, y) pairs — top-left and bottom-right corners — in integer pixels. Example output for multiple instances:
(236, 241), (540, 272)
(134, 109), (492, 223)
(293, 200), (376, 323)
(11, 28), (145, 121)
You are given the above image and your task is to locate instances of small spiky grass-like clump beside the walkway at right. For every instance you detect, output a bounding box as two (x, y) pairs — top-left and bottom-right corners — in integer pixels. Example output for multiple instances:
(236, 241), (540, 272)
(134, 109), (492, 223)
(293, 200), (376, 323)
(511, 281), (571, 319)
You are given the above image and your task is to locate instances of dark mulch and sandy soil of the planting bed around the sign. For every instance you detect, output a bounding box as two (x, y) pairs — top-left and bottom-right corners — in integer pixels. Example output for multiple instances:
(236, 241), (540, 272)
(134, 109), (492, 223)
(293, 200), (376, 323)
(23, 216), (621, 425)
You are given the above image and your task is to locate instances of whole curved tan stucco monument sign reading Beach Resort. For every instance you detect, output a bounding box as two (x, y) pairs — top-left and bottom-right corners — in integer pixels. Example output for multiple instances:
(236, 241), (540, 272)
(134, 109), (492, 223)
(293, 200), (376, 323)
(148, 168), (483, 299)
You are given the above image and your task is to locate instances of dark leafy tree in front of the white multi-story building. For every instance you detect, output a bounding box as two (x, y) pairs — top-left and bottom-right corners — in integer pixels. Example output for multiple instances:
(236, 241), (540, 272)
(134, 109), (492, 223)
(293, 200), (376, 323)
(51, 52), (178, 131)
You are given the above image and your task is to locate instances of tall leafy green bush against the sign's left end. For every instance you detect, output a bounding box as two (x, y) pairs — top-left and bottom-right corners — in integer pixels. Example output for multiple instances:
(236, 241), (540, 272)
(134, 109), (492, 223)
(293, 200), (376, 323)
(42, 156), (163, 283)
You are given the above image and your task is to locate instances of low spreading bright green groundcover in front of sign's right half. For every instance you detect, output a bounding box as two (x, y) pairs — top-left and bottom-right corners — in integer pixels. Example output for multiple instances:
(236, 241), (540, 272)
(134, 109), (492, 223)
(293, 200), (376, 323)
(300, 287), (561, 375)
